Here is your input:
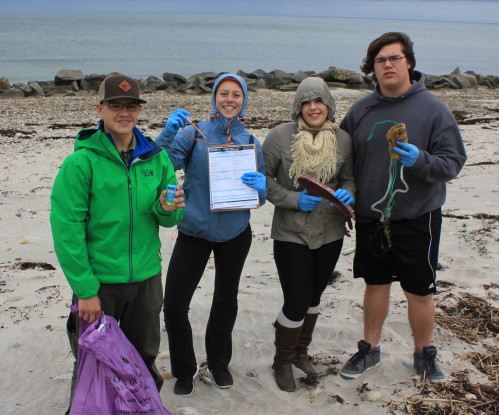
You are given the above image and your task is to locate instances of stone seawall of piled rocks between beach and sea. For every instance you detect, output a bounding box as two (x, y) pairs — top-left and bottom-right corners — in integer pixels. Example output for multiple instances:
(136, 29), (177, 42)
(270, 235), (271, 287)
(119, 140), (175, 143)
(0, 66), (499, 99)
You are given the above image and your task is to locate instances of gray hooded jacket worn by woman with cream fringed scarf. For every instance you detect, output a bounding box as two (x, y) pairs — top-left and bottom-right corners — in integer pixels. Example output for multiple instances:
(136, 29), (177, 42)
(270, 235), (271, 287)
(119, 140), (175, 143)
(262, 78), (355, 249)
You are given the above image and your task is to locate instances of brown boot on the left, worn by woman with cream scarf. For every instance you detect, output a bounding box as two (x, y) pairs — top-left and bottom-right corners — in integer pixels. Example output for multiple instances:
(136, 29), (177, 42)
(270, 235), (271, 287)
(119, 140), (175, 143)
(272, 321), (301, 392)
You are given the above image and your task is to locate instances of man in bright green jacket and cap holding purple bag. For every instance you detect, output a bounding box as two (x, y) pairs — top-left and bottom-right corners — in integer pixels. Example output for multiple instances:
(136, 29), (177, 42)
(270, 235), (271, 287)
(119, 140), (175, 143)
(50, 75), (185, 412)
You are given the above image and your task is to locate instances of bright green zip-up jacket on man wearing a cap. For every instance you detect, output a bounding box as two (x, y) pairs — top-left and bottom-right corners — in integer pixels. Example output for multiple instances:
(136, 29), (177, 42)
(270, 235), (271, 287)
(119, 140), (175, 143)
(50, 128), (183, 298)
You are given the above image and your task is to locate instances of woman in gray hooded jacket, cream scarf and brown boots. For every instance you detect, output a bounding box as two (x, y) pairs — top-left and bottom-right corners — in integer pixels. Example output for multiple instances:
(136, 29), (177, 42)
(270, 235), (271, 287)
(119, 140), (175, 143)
(263, 77), (355, 392)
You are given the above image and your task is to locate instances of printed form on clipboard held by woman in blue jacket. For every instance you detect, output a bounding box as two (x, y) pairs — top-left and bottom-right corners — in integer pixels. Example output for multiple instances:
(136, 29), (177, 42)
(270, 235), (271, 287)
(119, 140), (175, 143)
(208, 144), (260, 211)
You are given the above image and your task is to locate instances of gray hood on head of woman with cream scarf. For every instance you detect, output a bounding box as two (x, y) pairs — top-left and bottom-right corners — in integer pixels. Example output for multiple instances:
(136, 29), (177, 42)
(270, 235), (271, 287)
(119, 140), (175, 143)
(291, 76), (336, 121)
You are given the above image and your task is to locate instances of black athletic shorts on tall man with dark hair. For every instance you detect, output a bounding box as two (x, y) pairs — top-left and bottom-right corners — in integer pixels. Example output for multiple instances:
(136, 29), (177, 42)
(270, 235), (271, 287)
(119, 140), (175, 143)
(353, 208), (442, 296)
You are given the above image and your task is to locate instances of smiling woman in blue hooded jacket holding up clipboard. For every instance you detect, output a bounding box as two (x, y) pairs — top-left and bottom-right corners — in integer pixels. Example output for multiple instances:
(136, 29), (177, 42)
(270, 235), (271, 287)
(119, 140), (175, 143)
(156, 74), (267, 396)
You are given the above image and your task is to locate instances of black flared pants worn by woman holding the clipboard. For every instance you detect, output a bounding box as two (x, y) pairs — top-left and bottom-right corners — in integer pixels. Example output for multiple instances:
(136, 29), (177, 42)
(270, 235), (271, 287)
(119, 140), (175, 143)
(164, 225), (252, 379)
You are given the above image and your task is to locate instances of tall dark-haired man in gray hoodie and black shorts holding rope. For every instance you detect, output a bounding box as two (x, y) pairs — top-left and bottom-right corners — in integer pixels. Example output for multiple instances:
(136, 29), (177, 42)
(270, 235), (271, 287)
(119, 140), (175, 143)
(340, 32), (466, 381)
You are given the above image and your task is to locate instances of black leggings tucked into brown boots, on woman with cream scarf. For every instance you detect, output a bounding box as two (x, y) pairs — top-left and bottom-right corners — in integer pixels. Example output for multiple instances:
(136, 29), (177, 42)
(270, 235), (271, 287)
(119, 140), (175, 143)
(274, 238), (343, 321)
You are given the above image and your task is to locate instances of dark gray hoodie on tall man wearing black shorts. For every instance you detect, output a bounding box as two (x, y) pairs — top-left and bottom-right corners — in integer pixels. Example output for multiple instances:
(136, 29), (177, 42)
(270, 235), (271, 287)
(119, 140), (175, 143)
(341, 71), (466, 220)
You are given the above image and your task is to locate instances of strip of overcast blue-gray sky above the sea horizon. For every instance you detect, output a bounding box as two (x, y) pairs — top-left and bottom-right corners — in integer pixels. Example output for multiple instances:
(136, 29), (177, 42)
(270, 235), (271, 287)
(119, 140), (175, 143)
(0, 0), (499, 23)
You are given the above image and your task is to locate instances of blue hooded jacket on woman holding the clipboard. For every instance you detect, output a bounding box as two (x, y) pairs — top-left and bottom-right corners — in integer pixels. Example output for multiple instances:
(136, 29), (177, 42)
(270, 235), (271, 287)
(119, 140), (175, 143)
(156, 74), (266, 242)
